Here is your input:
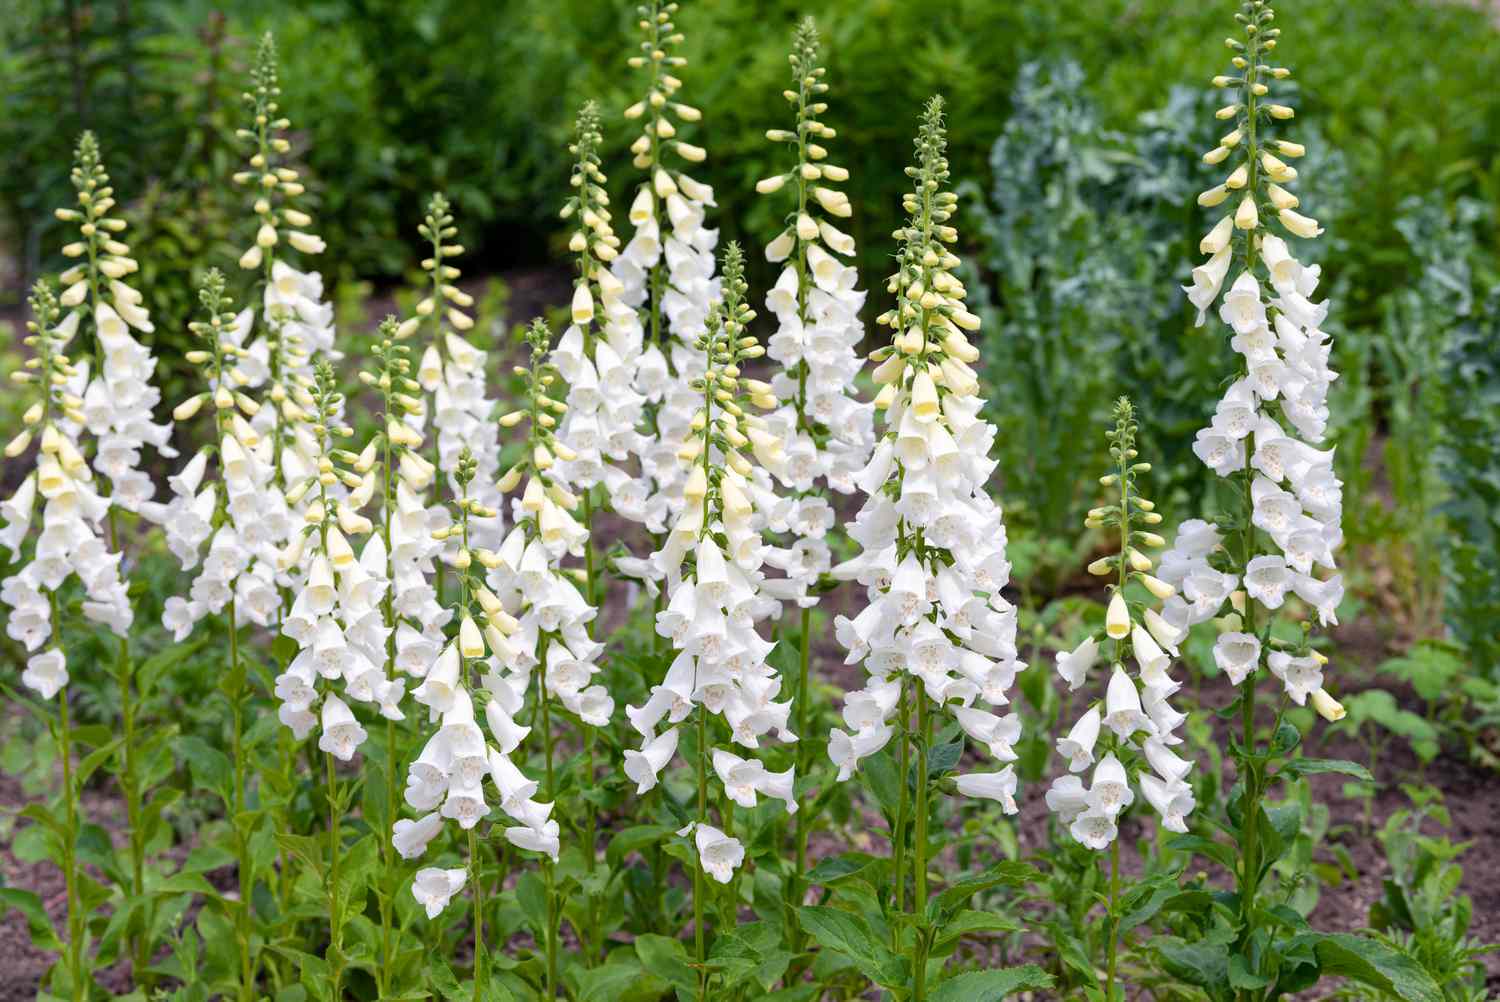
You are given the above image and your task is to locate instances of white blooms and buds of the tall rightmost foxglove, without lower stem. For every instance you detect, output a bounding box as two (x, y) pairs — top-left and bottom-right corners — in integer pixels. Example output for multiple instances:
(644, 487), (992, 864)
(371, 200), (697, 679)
(1161, 3), (1344, 717)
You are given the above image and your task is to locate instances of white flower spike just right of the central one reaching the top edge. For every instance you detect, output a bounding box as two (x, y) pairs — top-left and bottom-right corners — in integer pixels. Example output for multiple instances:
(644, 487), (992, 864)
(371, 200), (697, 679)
(756, 18), (875, 606)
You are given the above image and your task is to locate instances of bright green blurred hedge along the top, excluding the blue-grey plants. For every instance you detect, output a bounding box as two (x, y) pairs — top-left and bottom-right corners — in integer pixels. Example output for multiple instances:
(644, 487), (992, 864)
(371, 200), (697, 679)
(0, 0), (1500, 321)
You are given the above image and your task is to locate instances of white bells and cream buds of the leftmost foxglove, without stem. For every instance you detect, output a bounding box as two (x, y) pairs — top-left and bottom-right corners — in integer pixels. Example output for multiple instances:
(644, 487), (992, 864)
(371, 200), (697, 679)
(0, 282), (132, 699)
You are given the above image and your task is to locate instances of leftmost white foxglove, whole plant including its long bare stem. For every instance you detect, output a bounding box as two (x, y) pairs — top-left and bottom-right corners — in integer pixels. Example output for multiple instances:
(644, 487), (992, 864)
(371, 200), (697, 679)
(0, 282), (108, 1002)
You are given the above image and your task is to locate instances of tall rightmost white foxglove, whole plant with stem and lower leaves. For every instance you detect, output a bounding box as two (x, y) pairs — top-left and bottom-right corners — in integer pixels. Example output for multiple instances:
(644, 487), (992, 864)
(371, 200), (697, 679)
(1158, 7), (1398, 1002)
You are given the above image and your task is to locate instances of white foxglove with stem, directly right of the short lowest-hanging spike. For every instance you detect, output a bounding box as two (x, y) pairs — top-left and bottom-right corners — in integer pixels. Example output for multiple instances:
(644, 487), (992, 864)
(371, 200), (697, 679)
(483, 320), (615, 998)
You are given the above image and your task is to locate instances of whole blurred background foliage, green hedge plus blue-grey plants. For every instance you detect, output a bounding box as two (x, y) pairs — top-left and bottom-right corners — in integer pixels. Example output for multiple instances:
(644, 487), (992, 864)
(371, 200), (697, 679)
(0, 0), (1500, 675)
